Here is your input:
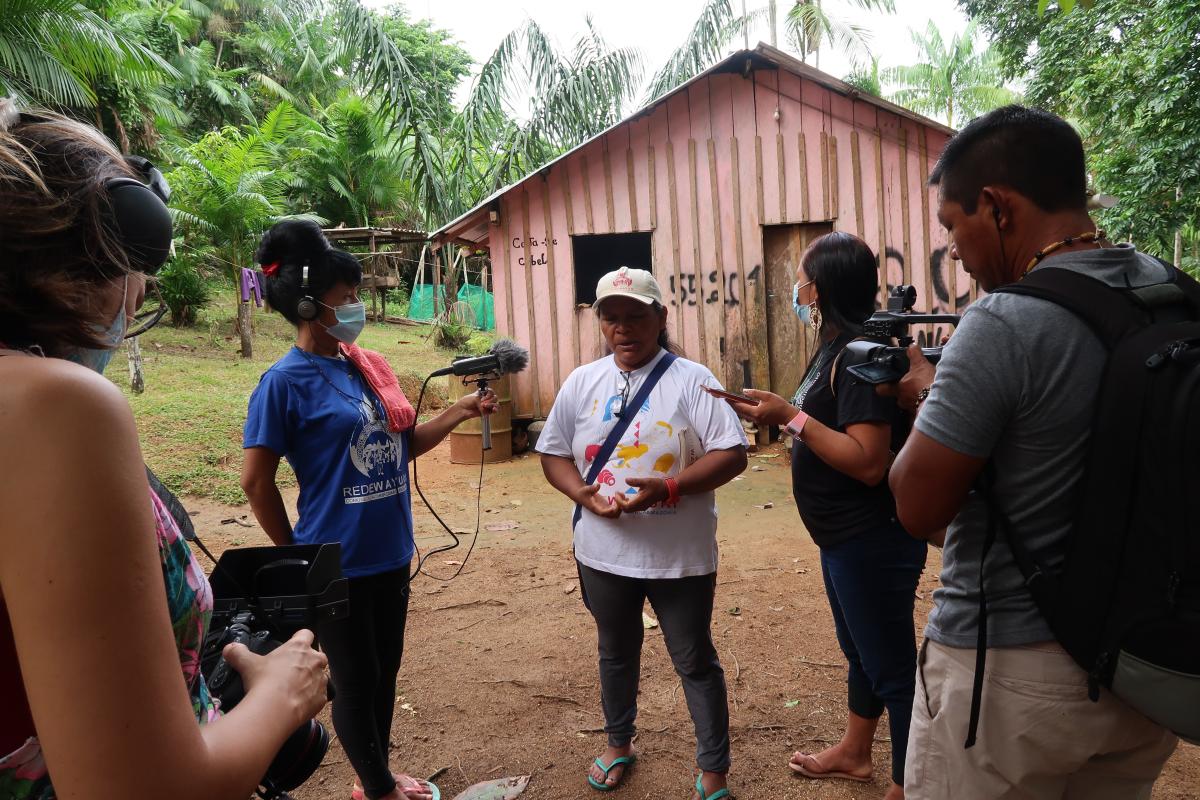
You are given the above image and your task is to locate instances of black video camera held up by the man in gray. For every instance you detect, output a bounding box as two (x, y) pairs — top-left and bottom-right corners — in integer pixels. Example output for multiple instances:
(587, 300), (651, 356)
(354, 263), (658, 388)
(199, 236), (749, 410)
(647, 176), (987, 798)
(844, 285), (960, 385)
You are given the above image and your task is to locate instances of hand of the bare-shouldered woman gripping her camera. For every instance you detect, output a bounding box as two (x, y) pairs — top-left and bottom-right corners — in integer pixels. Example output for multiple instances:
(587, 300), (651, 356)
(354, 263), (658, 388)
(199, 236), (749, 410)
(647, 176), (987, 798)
(221, 631), (329, 726)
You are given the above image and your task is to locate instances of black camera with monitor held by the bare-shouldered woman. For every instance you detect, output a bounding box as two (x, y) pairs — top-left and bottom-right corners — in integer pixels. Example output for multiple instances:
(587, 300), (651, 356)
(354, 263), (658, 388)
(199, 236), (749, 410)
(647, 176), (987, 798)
(200, 543), (349, 800)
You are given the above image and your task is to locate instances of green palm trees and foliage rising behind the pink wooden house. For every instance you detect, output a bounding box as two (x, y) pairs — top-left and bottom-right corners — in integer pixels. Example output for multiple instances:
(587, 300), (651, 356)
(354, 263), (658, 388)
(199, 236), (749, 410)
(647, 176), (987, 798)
(0, 0), (1180, 335)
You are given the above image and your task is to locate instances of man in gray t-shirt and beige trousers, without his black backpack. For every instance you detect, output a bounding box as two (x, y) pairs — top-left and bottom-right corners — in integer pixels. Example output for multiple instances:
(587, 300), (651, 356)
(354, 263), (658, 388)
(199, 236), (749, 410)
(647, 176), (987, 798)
(890, 106), (1176, 800)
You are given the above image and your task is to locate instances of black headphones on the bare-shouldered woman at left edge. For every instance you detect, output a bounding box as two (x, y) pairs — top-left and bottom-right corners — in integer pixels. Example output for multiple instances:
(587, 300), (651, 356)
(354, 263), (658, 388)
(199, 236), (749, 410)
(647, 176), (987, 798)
(104, 156), (174, 275)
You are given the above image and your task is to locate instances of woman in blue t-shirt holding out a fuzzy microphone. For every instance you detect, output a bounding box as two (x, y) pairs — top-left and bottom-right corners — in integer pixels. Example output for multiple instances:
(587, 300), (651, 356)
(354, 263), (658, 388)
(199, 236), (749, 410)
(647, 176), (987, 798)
(241, 219), (496, 800)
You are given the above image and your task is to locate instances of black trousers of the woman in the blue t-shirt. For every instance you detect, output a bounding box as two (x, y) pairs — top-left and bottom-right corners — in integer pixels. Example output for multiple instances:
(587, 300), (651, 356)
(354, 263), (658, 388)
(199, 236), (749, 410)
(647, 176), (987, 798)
(318, 565), (409, 798)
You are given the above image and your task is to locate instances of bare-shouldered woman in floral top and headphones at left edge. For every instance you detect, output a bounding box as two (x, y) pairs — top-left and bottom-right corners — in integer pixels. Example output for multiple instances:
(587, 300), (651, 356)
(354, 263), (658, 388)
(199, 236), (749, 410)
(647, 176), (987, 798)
(0, 101), (326, 800)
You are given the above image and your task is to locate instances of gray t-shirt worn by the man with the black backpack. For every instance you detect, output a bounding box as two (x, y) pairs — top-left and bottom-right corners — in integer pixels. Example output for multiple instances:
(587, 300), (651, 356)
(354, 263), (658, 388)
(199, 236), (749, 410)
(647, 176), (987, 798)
(916, 245), (1169, 648)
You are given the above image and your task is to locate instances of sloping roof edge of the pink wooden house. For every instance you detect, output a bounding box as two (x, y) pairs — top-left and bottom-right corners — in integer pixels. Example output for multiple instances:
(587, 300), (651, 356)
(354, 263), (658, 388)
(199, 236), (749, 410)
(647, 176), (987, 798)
(430, 42), (955, 240)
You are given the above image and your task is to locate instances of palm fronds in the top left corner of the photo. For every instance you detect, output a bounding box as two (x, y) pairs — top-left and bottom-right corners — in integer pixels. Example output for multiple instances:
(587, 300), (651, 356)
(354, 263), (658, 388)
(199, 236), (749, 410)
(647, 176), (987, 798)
(0, 0), (174, 109)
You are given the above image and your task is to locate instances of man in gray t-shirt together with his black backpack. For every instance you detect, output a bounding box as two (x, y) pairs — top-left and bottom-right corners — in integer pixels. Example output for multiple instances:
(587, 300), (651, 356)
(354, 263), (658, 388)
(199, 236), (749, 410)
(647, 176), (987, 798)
(889, 106), (1185, 800)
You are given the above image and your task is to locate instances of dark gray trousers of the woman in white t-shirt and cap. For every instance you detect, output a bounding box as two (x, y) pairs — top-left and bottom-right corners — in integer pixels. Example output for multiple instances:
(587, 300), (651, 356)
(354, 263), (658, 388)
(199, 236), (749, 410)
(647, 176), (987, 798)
(578, 564), (730, 772)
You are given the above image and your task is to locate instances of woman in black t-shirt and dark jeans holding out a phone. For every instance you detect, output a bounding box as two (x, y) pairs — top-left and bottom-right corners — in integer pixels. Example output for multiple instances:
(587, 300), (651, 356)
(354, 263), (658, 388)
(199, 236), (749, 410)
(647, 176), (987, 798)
(731, 231), (925, 800)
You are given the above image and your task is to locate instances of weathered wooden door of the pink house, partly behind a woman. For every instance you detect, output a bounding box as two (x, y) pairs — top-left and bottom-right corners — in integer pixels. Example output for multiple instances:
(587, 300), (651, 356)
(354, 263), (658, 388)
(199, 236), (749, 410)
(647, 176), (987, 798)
(762, 222), (833, 398)
